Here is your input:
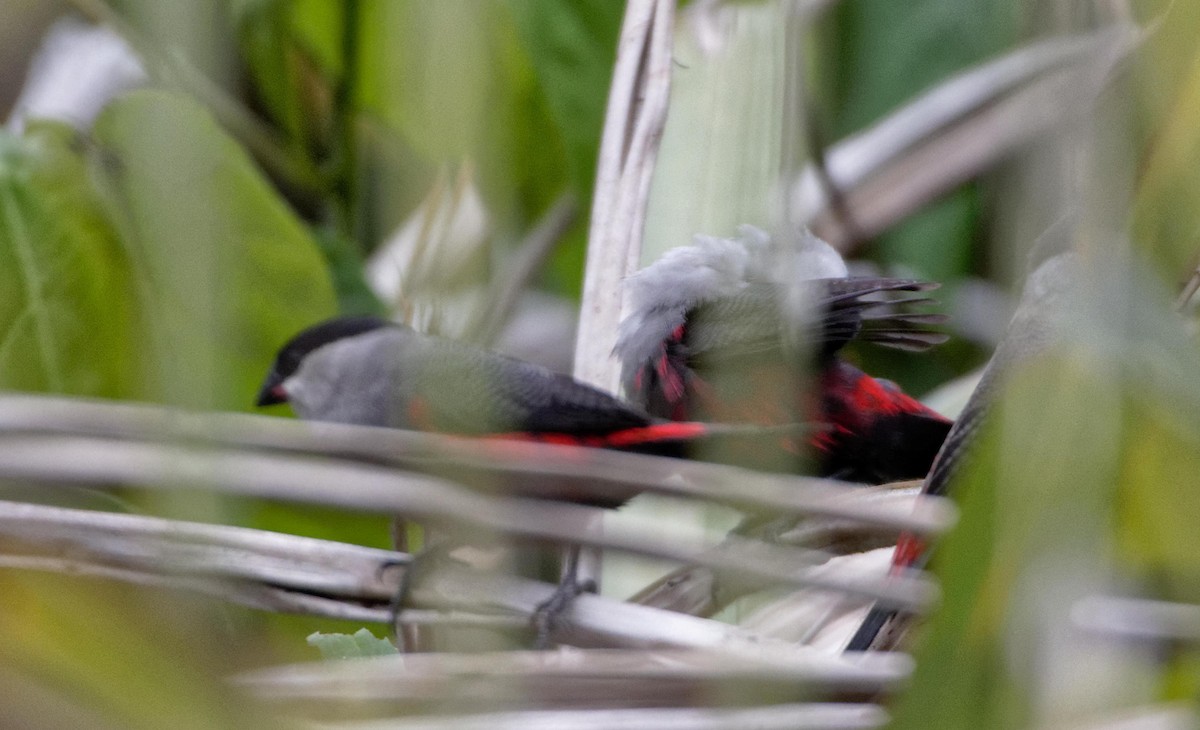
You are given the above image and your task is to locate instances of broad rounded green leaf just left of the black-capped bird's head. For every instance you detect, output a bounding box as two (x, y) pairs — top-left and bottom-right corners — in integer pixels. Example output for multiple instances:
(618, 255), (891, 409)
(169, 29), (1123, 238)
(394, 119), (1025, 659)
(96, 91), (335, 409)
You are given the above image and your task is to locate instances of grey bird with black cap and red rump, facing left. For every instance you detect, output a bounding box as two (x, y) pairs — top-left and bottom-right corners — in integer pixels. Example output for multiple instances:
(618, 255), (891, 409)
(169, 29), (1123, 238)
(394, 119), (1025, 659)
(256, 316), (729, 497)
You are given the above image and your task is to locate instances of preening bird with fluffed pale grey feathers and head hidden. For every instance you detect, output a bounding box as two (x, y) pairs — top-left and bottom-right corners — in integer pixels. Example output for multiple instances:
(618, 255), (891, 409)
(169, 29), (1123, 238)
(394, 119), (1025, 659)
(614, 226), (952, 484)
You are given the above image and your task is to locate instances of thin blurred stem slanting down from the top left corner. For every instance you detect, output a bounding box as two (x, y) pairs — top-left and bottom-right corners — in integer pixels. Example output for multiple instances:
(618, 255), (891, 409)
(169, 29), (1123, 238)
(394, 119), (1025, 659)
(70, 0), (326, 205)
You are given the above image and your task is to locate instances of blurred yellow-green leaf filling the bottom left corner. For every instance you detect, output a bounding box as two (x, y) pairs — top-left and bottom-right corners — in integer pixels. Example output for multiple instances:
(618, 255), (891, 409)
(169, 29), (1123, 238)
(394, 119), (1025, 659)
(0, 570), (272, 730)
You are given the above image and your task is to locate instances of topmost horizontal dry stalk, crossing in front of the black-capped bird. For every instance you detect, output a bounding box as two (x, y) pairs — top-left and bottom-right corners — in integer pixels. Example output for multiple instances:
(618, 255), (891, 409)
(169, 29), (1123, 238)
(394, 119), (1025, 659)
(0, 395), (954, 534)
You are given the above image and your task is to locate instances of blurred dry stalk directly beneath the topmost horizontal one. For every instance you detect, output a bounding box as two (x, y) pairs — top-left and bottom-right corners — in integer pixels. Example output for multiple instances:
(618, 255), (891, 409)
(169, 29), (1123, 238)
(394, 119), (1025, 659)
(0, 436), (936, 609)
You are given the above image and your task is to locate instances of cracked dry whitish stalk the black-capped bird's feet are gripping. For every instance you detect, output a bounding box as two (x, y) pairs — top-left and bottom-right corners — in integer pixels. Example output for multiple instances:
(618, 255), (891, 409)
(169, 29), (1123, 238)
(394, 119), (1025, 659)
(0, 502), (916, 653)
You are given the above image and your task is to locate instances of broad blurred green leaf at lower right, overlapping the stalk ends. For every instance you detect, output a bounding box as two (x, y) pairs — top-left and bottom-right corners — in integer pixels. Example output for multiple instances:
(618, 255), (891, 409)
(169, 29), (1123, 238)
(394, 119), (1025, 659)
(895, 353), (1152, 728)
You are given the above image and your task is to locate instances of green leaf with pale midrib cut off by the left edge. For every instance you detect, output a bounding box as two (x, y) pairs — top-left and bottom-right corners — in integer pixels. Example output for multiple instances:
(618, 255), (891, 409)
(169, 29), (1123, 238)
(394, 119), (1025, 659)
(0, 125), (138, 397)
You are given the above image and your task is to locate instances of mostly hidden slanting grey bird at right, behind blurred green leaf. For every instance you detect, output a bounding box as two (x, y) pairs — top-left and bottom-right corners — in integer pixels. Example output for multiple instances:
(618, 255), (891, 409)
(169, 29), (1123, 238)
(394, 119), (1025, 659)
(845, 242), (1082, 652)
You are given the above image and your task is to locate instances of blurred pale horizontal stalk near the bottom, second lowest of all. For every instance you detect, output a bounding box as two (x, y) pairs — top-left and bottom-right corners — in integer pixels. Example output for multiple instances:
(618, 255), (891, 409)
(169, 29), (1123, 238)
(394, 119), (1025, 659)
(235, 645), (912, 711)
